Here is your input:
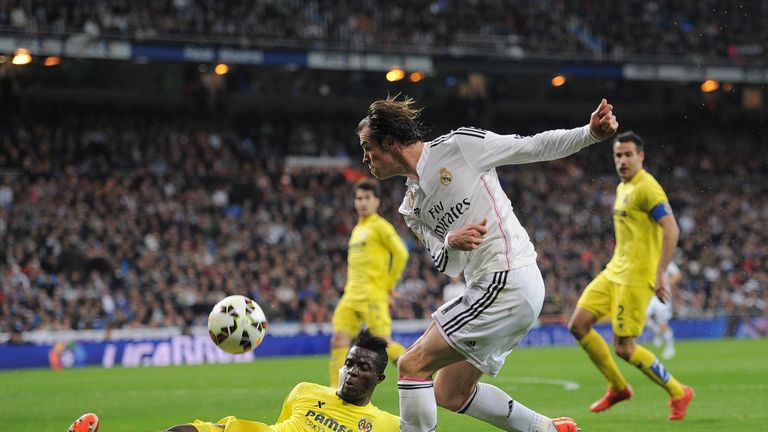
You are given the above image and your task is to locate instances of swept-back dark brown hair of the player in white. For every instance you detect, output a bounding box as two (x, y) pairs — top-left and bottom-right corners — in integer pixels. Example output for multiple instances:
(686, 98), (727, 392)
(357, 94), (424, 145)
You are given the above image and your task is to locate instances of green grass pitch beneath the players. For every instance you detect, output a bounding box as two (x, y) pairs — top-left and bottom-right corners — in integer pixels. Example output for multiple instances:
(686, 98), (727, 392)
(0, 339), (768, 432)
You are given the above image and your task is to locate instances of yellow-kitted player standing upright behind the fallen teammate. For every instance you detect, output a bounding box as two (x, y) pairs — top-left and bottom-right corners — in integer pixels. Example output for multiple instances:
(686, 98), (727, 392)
(328, 178), (408, 387)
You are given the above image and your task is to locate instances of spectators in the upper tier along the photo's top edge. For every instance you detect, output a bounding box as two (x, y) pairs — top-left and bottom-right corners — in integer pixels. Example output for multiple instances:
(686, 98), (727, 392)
(0, 0), (768, 59)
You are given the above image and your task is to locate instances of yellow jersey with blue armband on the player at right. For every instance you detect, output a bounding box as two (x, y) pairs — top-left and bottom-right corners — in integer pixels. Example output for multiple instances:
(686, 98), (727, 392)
(604, 169), (671, 286)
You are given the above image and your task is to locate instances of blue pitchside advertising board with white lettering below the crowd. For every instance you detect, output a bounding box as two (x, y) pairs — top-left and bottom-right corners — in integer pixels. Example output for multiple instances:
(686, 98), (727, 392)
(0, 317), (768, 369)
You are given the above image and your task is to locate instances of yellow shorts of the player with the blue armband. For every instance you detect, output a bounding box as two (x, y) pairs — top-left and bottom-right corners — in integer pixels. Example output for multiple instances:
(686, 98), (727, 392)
(576, 273), (654, 337)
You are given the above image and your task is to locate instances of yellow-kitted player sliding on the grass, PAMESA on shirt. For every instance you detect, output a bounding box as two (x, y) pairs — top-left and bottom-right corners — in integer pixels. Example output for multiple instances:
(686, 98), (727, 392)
(69, 330), (400, 432)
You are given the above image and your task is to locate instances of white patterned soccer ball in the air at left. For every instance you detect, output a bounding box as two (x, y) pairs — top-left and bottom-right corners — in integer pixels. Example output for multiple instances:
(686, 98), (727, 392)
(208, 295), (267, 354)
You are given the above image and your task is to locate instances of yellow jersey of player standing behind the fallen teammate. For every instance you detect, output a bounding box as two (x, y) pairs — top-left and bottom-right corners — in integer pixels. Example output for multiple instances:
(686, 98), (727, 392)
(344, 214), (408, 302)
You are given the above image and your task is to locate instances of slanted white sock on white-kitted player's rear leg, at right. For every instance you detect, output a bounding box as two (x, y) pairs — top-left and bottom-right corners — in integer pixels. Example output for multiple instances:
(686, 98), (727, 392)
(460, 383), (554, 432)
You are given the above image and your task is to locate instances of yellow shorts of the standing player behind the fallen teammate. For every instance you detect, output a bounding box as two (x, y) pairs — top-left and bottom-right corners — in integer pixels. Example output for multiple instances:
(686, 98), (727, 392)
(331, 296), (392, 338)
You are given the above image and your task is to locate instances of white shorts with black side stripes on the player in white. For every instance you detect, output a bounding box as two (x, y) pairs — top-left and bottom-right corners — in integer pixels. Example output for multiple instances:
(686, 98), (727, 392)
(432, 264), (544, 376)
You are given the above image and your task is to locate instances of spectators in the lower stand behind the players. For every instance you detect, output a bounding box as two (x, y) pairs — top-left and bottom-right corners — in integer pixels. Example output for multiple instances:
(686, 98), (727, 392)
(0, 114), (768, 338)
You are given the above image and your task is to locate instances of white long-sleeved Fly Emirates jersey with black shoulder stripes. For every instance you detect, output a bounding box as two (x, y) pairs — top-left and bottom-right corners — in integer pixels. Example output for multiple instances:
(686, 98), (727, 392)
(400, 125), (597, 285)
